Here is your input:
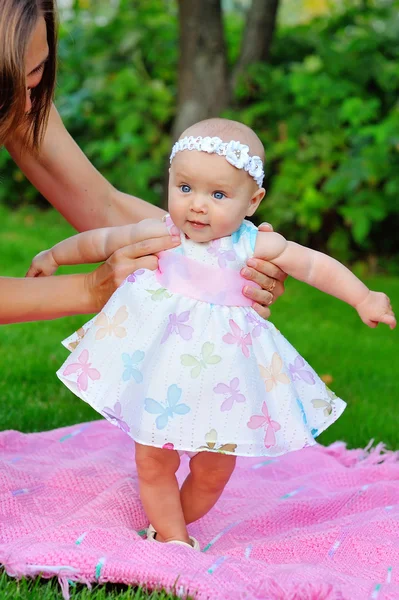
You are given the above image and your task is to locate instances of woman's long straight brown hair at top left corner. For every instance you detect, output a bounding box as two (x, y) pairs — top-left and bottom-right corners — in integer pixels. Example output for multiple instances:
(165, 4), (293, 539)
(0, 0), (57, 150)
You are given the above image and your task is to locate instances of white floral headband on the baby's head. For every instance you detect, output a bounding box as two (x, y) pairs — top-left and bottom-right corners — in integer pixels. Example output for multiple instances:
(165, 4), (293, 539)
(170, 135), (265, 188)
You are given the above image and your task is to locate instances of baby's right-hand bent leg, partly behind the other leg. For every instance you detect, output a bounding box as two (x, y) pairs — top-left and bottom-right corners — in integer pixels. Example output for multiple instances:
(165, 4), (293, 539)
(180, 451), (236, 524)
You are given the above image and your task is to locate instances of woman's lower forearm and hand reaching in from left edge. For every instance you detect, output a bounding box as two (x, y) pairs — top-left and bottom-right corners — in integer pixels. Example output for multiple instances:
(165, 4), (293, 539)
(0, 235), (177, 324)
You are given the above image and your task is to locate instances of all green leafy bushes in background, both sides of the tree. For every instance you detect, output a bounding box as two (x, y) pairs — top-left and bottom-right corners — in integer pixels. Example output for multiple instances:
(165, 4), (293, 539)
(0, 0), (399, 268)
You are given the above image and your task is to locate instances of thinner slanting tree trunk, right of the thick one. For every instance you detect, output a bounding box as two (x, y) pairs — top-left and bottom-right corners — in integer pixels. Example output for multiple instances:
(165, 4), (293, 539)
(231, 0), (279, 89)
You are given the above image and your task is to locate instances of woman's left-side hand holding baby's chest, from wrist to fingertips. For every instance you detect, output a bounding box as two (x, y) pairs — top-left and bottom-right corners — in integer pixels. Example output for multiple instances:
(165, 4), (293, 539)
(86, 235), (180, 312)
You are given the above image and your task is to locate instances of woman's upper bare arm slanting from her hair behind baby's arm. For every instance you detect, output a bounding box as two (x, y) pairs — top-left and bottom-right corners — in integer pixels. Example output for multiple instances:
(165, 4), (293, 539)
(7, 106), (165, 231)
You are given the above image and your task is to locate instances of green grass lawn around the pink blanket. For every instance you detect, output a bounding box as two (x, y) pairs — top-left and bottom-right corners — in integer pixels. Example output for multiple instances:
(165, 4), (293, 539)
(0, 207), (399, 600)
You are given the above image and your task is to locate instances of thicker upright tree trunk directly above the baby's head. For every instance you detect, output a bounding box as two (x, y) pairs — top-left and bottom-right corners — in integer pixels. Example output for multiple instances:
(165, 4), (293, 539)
(173, 0), (229, 140)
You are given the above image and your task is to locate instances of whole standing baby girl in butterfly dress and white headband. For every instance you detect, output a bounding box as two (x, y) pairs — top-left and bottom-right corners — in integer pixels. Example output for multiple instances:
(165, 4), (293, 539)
(29, 119), (396, 549)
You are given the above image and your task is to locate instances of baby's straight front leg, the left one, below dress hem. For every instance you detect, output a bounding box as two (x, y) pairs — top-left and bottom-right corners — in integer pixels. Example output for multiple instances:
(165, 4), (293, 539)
(136, 442), (190, 543)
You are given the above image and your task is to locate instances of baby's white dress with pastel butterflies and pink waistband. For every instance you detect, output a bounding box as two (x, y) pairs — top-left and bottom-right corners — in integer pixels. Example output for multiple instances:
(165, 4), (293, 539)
(57, 217), (346, 456)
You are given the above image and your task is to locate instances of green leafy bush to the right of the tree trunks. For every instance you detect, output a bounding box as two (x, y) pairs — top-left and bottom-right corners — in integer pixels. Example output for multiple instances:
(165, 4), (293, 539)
(235, 1), (399, 260)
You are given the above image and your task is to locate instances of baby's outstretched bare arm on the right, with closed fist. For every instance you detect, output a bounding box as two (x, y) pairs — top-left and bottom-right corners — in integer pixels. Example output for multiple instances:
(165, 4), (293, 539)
(255, 232), (396, 329)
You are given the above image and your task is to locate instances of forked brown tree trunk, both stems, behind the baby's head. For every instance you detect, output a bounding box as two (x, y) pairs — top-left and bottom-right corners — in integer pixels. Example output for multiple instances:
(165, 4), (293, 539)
(163, 0), (279, 208)
